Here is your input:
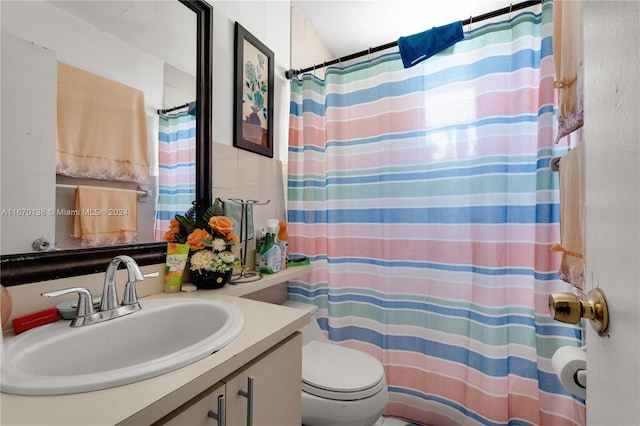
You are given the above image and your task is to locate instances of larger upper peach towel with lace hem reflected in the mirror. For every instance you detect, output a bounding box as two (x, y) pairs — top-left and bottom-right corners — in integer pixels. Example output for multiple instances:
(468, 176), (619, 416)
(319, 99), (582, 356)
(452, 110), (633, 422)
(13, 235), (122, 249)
(56, 62), (149, 184)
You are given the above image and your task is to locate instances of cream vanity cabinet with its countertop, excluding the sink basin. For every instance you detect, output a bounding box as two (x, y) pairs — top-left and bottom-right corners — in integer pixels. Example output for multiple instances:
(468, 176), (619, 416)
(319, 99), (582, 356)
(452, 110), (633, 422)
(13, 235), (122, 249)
(0, 294), (309, 426)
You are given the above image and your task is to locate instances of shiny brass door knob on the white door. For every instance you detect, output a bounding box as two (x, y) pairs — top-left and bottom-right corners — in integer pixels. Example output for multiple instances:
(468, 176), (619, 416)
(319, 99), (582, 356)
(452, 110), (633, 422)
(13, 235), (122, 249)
(549, 288), (609, 335)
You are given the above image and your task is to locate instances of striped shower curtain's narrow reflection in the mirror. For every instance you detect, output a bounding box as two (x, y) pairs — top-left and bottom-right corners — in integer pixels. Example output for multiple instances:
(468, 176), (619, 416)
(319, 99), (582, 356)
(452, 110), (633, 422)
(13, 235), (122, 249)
(154, 110), (196, 241)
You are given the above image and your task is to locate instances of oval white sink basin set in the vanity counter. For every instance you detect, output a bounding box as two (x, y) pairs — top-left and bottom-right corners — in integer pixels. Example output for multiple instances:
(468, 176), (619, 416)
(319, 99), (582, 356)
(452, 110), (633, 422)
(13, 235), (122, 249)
(0, 298), (244, 395)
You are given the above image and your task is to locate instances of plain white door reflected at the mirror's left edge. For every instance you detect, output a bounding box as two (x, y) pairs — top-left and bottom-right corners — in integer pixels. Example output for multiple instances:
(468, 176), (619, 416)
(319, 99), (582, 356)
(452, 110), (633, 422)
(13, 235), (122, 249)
(0, 33), (58, 253)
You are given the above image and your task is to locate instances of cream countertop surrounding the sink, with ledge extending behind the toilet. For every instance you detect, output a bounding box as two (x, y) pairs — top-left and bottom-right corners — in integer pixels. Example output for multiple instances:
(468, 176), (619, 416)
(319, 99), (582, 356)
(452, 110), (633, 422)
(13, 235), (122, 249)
(0, 267), (309, 426)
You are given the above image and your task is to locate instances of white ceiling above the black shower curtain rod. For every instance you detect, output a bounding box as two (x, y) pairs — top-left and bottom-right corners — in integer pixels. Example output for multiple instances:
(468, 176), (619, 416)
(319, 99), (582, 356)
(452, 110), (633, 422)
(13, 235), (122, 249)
(291, 0), (518, 59)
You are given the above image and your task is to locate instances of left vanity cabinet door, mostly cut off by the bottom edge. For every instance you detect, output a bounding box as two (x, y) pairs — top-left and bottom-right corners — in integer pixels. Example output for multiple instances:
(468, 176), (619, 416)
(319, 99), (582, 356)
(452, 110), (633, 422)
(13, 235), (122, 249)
(156, 383), (229, 426)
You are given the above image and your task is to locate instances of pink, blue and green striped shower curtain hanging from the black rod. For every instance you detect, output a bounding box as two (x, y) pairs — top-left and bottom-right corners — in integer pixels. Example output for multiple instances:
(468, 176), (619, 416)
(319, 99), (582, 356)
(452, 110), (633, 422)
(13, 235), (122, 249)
(288, 2), (585, 425)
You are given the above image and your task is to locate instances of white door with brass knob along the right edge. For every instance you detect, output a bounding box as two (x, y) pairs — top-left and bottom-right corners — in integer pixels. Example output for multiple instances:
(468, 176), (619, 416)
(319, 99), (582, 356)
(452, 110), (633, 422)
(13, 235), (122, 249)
(583, 0), (640, 426)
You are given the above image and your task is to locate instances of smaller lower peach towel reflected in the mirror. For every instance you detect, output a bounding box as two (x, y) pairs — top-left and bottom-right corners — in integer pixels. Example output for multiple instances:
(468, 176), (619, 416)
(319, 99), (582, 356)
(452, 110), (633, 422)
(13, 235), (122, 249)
(73, 185), (138, 247)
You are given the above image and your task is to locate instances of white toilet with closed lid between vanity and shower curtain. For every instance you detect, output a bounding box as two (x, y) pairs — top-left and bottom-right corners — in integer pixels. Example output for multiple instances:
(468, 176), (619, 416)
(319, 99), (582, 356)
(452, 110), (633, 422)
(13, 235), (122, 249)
(283, 300), (389, 426)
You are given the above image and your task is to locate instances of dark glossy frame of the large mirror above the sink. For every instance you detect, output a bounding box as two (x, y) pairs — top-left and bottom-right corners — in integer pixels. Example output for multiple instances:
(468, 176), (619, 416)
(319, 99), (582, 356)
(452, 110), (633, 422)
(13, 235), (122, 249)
(0, 0), (213, 286)
